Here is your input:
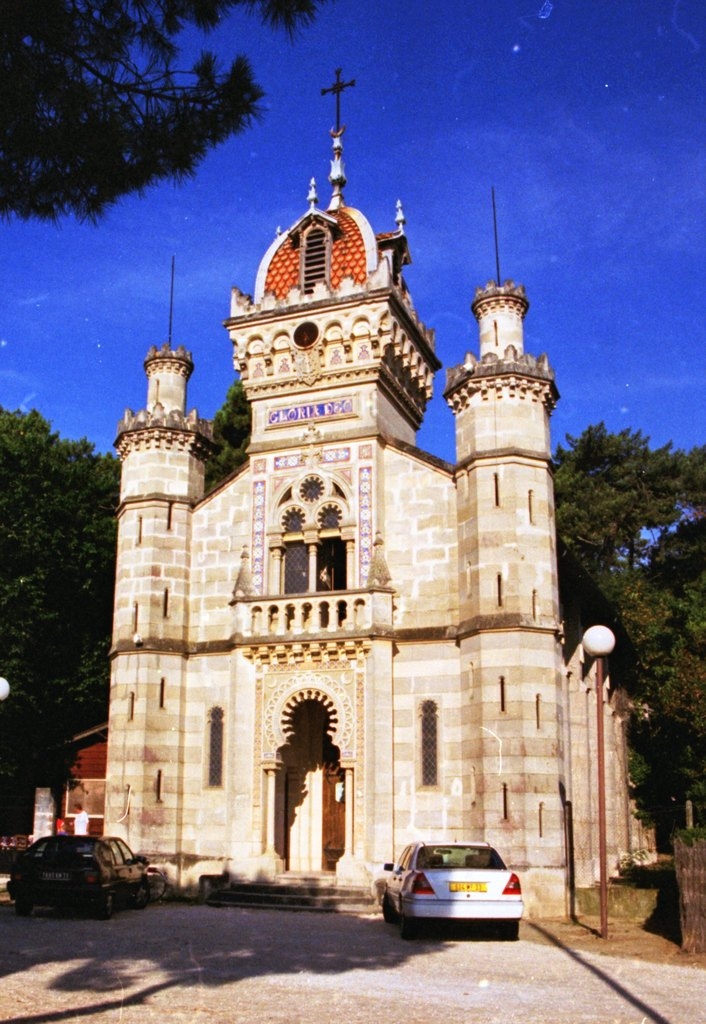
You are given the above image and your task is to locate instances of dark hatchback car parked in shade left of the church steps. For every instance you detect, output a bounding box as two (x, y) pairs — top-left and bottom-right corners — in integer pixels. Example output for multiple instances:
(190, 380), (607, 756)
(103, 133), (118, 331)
(7, 836), (150, 920)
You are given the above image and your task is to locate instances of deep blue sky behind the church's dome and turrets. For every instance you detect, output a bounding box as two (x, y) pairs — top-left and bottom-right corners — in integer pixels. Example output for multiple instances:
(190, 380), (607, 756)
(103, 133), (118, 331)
(0, 0), (706, 460)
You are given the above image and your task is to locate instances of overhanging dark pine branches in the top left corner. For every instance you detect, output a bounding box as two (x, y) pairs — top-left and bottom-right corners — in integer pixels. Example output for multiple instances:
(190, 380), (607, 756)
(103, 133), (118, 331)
(0, 0), (323, 219)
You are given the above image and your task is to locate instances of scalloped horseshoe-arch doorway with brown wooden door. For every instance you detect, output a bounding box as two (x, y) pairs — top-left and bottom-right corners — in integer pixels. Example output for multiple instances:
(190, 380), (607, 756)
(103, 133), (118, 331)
(277, 694), (345, 873)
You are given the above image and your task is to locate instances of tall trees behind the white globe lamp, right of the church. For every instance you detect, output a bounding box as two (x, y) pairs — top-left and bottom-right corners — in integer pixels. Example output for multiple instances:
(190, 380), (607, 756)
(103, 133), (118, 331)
(555, 424), (706, 844)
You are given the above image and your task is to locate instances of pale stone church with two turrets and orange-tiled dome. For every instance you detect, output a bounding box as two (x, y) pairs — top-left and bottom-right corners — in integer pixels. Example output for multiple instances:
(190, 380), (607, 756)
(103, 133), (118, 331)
(106, 138), (631, 913)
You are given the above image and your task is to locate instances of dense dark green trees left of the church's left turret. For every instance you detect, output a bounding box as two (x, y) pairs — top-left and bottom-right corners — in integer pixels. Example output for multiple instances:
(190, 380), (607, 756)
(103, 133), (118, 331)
(0, 409), (120, 815)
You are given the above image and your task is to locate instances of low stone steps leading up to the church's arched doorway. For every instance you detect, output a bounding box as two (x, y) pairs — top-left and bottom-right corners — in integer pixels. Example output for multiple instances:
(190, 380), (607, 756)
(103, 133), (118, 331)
(206, 873), (379, 913)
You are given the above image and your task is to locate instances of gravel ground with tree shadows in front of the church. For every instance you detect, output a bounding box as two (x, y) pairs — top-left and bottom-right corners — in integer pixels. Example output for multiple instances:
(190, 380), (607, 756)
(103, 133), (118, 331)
(0, 903), (706, 1024)
